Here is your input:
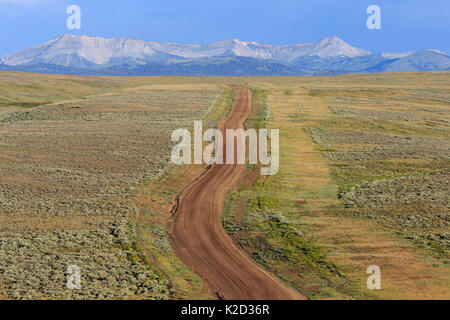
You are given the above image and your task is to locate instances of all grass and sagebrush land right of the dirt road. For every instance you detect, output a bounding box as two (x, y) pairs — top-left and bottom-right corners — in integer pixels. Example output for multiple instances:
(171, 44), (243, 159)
(224, 73), (450, 299)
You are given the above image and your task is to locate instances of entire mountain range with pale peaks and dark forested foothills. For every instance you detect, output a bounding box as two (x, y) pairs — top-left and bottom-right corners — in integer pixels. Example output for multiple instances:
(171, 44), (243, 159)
(0, 34), (450, 76)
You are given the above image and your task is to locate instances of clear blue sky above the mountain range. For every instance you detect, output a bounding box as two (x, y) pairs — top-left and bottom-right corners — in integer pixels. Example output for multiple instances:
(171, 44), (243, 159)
(0, 0), (450, 56)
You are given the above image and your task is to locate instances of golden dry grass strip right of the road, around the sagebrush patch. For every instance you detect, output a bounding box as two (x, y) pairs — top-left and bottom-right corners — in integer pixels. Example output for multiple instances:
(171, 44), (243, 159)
(235, 72), (450, 299)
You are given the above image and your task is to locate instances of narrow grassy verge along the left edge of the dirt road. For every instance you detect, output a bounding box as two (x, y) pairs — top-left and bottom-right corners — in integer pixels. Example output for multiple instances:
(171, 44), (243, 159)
(135, 87), (235, 299)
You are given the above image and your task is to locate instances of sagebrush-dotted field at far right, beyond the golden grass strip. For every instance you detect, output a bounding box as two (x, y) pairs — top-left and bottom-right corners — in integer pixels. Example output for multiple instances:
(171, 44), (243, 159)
(302, 74), (450, 265)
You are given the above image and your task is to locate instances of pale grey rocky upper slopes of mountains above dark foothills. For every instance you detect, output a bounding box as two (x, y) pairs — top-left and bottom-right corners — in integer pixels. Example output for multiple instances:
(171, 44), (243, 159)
(1, 34), (370, 67)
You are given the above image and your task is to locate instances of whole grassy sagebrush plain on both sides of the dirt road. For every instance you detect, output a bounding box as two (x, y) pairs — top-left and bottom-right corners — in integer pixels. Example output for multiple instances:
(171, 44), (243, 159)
(0, 72), (450, 299)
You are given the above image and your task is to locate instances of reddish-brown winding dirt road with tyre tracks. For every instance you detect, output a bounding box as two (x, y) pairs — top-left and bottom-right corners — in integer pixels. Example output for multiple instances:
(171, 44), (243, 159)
(169, 86), (305, 300)
